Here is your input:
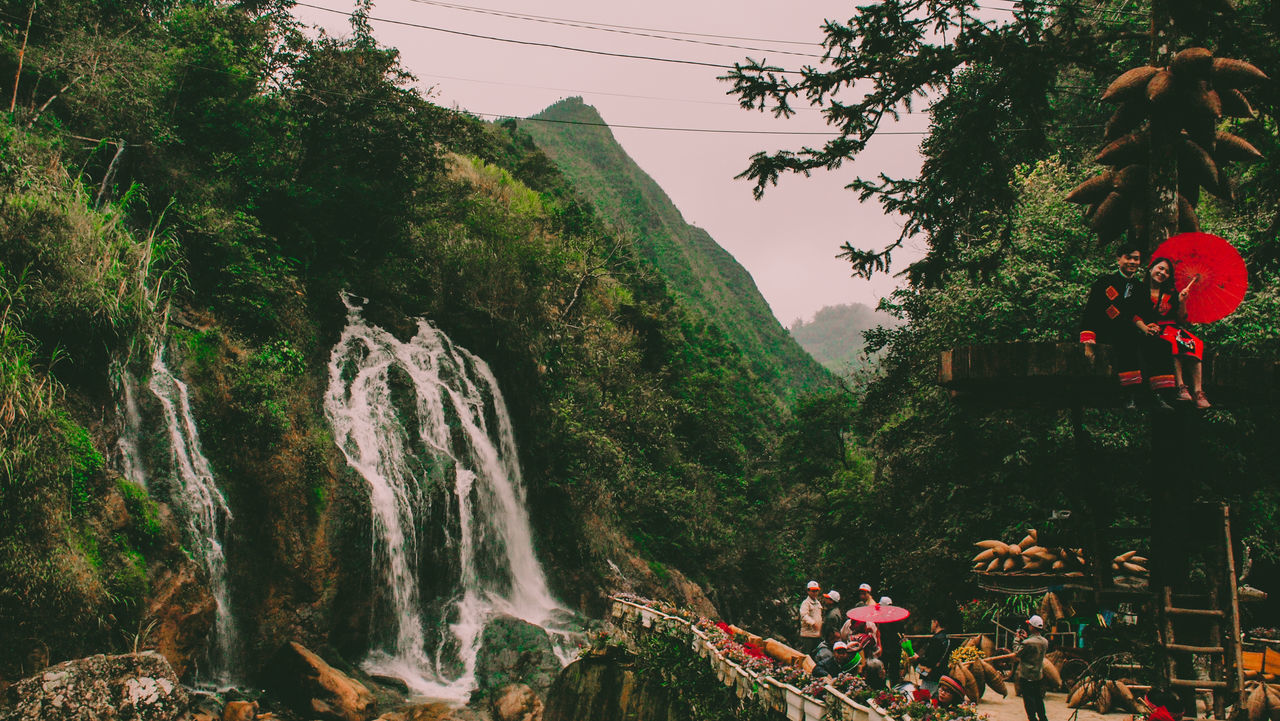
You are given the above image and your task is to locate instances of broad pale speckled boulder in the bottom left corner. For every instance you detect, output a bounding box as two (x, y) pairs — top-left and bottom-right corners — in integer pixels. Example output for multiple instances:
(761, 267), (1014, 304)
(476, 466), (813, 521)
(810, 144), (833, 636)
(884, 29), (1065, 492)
(0, 652), (188, 721)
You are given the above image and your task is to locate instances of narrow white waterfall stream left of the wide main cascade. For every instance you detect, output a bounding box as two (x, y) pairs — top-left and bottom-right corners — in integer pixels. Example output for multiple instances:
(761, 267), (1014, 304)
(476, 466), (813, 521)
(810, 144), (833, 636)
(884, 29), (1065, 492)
(148, 348), (237, 686)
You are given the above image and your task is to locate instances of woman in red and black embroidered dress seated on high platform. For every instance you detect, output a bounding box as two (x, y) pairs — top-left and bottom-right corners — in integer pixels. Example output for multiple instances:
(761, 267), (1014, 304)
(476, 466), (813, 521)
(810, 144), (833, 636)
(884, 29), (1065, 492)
(1133, 257), (1210, 410)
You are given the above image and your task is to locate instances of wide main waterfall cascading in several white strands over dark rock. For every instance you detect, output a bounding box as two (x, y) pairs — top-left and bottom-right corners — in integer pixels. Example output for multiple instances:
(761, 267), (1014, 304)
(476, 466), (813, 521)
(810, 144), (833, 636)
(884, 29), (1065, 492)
(324, 296), (566, 701)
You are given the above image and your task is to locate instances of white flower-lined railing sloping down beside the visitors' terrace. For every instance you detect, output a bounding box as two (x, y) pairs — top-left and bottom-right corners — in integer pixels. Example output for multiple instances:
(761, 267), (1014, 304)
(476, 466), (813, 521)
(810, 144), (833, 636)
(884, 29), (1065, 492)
(609, 598), (890, 721)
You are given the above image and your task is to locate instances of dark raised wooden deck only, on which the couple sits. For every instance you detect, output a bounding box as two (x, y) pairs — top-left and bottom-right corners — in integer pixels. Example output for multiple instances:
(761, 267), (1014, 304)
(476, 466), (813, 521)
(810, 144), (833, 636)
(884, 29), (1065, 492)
(938, 342), (1280, 409)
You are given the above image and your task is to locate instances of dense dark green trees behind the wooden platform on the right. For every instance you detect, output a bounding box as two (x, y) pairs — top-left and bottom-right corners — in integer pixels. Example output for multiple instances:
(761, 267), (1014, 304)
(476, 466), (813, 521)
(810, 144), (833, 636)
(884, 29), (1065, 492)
(735, 0), (1280, 622)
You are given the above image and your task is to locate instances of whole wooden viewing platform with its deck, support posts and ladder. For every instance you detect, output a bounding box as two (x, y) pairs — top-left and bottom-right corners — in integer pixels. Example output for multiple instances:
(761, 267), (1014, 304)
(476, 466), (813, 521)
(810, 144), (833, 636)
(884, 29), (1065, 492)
(938, 342), (1280, 718)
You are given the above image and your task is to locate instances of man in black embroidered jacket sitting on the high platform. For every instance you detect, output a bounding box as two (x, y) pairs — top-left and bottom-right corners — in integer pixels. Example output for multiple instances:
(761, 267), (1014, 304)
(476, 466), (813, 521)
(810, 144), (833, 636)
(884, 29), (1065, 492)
(1080, 243), (1174, 410)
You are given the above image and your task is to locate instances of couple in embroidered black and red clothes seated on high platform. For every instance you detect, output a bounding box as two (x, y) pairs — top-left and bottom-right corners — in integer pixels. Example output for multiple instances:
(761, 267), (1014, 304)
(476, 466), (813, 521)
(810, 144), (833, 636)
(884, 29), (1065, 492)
(1080, 245), (1210, 410)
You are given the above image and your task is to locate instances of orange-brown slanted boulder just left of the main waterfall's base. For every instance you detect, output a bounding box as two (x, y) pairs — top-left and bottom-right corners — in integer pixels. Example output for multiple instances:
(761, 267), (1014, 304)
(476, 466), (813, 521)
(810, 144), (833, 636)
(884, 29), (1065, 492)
(268, 642), (378, 721)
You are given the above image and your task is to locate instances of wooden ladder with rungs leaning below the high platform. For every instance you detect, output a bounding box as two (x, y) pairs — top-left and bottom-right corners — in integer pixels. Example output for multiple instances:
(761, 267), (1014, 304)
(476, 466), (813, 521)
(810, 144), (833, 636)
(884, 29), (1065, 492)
(1157, 505), (1244, 718)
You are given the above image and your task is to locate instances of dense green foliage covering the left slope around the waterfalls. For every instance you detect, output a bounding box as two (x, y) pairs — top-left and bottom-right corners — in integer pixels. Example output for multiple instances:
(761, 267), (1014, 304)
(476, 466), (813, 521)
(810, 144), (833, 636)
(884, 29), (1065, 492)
(0, 0), (826, 675)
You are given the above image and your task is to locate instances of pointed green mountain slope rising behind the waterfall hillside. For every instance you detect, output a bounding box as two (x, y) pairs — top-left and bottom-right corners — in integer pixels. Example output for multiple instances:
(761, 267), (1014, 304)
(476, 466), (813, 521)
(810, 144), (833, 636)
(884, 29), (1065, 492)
(520, 97), (828, 398)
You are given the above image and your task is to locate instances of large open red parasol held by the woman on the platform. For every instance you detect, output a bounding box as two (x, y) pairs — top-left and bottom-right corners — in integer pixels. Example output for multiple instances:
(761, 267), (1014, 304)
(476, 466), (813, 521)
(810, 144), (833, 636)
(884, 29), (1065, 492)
(1151, 233), (1249, 323)
